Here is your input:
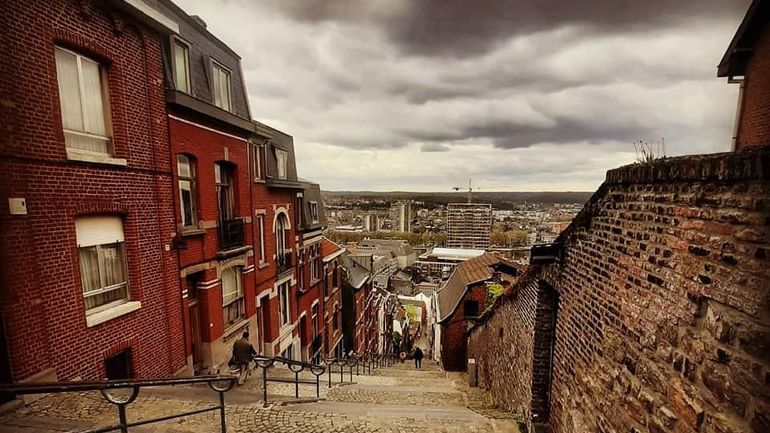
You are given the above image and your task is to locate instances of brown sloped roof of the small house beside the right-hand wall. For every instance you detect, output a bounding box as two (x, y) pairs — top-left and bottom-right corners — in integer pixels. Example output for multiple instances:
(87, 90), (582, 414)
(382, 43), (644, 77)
(436, 254), (518, 322)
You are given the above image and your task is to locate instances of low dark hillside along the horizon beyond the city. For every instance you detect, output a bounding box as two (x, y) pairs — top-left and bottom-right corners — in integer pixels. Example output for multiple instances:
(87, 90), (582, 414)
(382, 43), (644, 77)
(323, 191), (593, 209)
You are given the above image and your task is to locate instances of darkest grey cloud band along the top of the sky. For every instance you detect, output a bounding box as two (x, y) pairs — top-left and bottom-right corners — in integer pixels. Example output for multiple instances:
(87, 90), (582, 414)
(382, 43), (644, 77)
(268, 0), (750, 57)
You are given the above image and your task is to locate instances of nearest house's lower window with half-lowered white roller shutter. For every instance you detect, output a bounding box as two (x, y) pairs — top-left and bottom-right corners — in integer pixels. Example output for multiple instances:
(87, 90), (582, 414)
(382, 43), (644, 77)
(75, 216), (129, 314)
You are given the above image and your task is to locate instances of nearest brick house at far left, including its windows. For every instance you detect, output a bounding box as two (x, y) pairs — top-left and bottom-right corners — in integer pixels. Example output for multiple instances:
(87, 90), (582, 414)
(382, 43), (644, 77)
(0, 0), (185, 382)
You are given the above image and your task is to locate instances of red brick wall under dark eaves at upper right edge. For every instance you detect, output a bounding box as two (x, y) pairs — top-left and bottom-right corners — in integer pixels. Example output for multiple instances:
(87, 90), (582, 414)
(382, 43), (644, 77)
(736, 25), (770, 149)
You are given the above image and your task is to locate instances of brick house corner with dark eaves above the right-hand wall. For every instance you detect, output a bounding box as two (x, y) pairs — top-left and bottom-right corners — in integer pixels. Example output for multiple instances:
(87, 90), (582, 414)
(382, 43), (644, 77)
(717, 0), (770, 150)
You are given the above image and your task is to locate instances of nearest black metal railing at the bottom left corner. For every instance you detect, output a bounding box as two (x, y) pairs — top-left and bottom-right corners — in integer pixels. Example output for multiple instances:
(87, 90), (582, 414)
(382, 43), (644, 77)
(0, 373), (234, 433)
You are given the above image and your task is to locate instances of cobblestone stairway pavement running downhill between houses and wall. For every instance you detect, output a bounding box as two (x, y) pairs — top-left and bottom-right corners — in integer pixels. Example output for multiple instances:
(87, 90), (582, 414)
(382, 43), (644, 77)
(0, 362), (518, 433)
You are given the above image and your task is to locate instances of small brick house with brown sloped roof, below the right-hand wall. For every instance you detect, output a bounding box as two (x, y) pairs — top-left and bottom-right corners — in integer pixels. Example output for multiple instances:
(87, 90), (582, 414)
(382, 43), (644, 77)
(434, 254), (518, 371)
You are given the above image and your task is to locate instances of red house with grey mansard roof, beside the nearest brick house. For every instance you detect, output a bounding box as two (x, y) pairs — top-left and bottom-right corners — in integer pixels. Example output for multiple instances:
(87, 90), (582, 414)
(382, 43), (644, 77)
(158, 0), (258, 372)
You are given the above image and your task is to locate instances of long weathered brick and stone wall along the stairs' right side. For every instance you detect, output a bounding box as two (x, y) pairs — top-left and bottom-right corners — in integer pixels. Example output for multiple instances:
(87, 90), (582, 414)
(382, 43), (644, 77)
(470, 149), (770, 433)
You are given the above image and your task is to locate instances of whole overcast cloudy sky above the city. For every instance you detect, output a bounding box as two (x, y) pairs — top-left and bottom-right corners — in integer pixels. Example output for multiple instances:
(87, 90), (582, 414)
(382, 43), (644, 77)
(175, 0), (750, 191)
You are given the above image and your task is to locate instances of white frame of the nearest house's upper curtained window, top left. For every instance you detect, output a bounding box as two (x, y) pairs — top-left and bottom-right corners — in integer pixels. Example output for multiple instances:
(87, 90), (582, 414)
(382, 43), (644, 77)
(54, 45), (114, 156)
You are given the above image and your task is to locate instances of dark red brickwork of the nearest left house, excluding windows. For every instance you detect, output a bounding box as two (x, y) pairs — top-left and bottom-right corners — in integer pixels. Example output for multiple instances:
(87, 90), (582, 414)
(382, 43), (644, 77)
(0, 0), (185, 380)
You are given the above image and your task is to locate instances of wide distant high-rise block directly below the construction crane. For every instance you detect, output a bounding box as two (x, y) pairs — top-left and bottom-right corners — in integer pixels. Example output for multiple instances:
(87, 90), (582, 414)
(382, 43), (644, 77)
(446, 203), (492, 250)
